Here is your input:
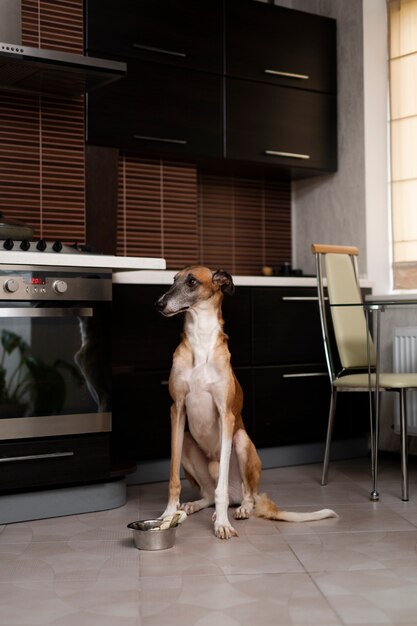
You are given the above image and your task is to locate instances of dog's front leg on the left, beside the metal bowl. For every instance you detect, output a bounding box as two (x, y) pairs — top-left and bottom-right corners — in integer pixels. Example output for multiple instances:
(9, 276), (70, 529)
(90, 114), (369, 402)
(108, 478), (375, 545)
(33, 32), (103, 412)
(161, 401), (185, 517)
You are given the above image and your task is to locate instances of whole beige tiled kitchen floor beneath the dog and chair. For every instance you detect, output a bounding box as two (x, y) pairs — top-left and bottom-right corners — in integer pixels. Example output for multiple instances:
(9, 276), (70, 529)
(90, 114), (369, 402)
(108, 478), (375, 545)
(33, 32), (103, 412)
(0, 459), (417, 626)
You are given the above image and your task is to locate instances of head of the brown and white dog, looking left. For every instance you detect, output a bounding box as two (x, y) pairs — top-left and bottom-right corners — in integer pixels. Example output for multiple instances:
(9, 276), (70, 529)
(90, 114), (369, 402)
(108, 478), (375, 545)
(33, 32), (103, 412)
(155, 265), (235, 317)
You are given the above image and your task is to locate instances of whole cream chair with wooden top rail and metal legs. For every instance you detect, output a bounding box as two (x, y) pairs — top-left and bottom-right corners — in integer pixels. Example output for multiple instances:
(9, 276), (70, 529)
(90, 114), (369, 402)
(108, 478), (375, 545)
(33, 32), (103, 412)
(311, 244), (417, 501)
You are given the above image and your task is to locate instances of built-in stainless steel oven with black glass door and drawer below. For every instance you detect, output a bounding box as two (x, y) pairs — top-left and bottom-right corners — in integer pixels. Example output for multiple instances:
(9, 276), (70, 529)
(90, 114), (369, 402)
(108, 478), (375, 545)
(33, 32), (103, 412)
(0, 265), (112, 489)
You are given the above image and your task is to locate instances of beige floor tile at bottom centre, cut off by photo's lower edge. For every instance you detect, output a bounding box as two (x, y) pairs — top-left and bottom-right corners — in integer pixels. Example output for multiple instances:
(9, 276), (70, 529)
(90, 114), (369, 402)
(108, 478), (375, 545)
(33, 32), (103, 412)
(142, 573), (342, 626)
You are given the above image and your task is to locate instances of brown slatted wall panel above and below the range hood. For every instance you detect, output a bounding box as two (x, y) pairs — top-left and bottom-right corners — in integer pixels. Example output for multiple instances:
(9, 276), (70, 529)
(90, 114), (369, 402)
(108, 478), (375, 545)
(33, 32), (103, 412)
(0, 0), (85, 243)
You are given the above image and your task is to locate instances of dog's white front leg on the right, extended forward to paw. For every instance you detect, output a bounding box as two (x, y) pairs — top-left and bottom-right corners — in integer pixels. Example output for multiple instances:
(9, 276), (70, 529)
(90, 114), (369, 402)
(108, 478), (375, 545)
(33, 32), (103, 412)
(213, 411), (238, 539)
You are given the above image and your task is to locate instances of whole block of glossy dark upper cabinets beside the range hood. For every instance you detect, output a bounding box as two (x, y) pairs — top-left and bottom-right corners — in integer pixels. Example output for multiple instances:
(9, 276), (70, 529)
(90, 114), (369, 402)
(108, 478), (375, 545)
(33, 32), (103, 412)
(86, 0), (337, 178)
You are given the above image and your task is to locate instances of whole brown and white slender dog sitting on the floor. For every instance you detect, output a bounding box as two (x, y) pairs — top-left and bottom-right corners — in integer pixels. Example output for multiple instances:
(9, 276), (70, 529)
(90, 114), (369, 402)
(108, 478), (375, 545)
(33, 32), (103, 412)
(156, 266), (337, 539)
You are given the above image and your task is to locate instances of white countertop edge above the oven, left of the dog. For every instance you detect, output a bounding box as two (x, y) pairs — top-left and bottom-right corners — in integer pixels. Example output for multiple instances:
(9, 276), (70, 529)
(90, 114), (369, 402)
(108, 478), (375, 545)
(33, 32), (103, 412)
(0, 251), (166, 271)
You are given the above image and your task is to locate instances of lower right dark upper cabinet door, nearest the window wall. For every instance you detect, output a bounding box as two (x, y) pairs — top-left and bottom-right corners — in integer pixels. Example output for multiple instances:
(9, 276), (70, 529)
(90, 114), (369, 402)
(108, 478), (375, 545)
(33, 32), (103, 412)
(226, 78), (337, 171)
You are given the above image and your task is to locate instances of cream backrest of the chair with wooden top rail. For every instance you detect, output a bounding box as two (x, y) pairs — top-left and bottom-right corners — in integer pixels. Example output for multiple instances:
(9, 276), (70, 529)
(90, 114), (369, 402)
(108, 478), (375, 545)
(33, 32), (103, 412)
(311, 244), (375, 380)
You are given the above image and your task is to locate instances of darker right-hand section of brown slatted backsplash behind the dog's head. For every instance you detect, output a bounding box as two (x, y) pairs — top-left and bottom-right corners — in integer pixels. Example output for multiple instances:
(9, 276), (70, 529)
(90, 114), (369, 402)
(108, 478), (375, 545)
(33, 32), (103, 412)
(199, 174), (292, 275)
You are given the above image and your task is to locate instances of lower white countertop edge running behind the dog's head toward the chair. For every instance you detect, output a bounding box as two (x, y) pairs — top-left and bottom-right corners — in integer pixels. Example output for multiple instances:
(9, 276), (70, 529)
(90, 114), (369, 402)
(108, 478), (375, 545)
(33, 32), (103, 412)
(113, 270), (372, 287)
